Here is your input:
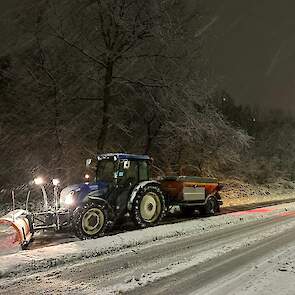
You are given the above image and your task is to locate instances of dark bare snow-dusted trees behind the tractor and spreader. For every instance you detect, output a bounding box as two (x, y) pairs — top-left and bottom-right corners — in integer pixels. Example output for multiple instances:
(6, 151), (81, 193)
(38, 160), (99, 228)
(0, 0), (288, 194)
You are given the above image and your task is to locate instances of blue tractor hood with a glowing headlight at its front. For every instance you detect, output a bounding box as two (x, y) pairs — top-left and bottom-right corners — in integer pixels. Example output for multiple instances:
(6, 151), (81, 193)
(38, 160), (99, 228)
(60, 181), (109, 208)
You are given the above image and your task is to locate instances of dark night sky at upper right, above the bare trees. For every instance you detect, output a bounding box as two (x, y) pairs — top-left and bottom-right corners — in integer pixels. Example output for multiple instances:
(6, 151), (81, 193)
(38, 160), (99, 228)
(0, 0), (295, 111)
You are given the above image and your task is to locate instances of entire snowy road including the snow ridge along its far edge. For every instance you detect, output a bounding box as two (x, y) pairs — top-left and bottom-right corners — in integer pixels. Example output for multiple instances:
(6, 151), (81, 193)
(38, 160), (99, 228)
(0, 203), (295, 295)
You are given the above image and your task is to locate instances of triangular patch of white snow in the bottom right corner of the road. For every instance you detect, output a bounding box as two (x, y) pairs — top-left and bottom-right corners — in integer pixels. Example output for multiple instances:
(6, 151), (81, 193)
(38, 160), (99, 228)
(196, 243), (295, 295)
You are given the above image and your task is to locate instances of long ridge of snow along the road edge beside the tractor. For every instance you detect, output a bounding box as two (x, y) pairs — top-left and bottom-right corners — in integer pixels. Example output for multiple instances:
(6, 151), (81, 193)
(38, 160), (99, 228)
(0, 203), (295, 277)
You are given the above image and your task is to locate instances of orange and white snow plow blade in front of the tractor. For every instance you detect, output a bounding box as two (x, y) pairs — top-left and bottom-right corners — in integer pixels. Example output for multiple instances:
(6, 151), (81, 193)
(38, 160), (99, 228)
(0, 209), (33, 254)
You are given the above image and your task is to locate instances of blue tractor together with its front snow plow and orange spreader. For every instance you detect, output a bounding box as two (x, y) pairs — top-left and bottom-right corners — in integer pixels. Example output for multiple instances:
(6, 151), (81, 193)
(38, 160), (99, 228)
(0, 153), (222, 246)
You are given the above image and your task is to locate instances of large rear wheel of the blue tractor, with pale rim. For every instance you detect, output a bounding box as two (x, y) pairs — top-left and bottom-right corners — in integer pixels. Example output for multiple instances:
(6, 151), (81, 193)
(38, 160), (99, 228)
(130, 185), (165, 228)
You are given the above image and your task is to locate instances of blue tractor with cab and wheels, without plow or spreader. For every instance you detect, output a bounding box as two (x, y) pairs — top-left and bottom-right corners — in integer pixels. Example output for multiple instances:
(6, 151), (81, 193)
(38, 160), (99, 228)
(58, 153), (166, 239)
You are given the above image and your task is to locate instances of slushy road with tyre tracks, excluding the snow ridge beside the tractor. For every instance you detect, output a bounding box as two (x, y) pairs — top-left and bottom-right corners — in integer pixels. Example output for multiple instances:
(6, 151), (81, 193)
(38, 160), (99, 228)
(0, 204), (295, 295)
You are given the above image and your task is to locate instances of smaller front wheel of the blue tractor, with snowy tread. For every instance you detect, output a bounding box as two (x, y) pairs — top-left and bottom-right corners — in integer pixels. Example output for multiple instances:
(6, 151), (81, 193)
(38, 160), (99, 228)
(72, 202), (109, 240)
